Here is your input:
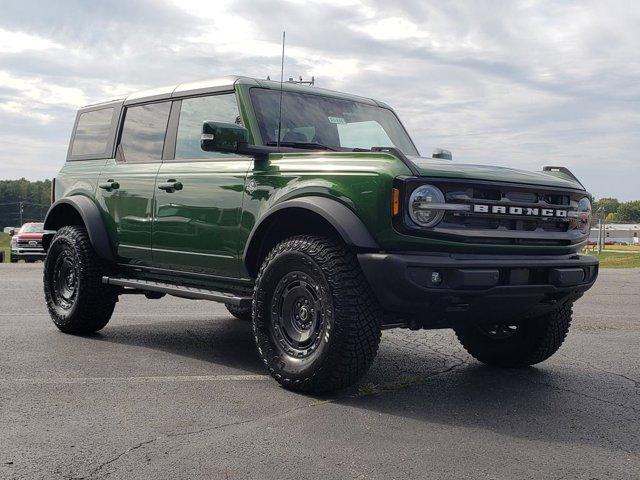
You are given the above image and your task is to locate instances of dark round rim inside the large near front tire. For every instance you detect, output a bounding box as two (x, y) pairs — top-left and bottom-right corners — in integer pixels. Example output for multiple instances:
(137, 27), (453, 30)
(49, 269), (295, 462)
(271, 271), (326, 358)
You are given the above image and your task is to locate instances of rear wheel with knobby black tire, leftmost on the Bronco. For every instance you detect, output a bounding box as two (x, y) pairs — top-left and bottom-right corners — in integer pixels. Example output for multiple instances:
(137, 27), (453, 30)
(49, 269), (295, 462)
(43, 226), (118, 335)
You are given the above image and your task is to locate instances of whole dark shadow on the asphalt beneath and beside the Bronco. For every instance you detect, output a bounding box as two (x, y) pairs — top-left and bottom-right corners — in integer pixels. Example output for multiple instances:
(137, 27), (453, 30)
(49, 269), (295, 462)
(93, 318), (640, 454)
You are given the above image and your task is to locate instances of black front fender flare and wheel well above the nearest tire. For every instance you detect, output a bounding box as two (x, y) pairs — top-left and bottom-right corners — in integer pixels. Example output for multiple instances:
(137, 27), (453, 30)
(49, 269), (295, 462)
(243, 196), (380, 277)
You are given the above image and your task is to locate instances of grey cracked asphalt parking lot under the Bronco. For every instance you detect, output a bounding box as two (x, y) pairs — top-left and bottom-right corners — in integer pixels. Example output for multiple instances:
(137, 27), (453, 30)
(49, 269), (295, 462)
(0, 264), (640, 480)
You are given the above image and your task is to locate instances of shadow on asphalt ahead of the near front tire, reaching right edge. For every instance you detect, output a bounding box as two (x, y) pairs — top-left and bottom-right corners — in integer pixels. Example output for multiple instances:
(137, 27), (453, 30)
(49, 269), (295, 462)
(336, 352), (640, 455)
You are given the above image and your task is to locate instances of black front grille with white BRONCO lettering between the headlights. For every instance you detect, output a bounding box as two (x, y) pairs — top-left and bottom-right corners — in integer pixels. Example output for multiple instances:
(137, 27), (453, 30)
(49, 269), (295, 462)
(394, 177), (588, 247)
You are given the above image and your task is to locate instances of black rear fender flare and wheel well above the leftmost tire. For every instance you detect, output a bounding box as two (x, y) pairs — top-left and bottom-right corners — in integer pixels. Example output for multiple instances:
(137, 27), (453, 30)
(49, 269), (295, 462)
(42, 195), (115, 262)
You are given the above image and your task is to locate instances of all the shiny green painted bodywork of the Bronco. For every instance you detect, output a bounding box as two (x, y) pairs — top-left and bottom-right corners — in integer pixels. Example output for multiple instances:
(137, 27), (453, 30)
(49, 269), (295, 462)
(56, 79), (582, 289)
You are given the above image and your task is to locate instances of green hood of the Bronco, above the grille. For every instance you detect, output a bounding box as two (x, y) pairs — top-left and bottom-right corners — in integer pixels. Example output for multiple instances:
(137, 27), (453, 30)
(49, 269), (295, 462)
(408, 156), (584, 190)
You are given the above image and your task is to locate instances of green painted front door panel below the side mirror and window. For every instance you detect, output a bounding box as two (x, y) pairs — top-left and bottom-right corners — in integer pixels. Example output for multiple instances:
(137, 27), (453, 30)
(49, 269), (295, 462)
(153, 155), (253, 277)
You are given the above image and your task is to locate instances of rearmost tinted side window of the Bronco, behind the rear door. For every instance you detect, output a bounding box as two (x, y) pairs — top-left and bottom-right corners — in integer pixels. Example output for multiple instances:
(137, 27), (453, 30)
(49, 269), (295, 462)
(71, 107), (113, 156)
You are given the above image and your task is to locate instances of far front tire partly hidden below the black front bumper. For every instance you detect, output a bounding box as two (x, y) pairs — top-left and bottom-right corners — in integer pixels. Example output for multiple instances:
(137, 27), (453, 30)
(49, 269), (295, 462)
(456, 303), (573, 368)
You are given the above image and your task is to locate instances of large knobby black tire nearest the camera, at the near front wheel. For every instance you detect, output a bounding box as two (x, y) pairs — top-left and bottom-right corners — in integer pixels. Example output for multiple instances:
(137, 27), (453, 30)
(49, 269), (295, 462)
(252, 235), (382, 393)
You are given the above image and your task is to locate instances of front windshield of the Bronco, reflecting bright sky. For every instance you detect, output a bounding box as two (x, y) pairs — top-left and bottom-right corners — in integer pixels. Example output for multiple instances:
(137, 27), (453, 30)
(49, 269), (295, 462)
(251, 88), (418, 155)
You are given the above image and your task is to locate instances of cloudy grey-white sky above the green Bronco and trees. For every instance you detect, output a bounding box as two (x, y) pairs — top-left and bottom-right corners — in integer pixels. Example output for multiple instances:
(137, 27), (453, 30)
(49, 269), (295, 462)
(0, 0), (640, 200)
